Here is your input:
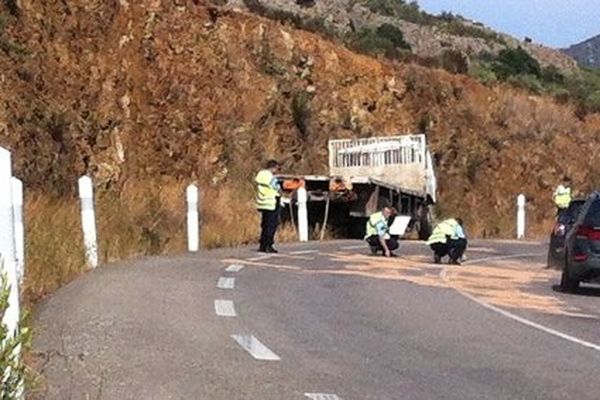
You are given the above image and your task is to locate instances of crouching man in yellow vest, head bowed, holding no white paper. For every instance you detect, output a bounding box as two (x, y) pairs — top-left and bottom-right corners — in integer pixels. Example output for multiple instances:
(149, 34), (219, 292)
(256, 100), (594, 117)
(427, 218), (467, 265)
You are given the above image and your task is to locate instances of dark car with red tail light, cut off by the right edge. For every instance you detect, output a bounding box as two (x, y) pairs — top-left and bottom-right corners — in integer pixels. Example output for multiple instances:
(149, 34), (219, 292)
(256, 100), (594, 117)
(560, 192), (600, 292)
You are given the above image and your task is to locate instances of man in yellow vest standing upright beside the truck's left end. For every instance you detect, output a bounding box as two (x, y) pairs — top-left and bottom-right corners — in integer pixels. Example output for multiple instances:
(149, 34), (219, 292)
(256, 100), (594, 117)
(254, 160), (281, 253)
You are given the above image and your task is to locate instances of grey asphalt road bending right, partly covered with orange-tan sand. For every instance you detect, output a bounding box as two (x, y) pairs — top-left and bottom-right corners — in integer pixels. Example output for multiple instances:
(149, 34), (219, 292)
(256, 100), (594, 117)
(30, 242), (600, 400)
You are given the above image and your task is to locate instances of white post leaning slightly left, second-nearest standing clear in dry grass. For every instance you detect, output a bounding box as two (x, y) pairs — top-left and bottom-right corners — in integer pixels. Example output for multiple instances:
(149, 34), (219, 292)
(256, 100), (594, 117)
(79, 176), (98, 268)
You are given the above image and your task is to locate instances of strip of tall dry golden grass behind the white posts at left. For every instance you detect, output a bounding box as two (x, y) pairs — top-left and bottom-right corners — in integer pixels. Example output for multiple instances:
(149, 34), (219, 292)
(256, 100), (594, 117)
(24, 180), (304, 302)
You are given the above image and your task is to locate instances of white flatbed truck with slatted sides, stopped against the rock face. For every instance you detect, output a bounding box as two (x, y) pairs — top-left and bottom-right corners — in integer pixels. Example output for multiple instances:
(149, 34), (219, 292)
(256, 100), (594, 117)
(282, 135), (437, 239)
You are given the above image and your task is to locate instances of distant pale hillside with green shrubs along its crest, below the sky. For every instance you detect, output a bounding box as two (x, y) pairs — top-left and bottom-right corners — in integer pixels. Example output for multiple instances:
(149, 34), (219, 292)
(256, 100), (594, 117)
(219, 0), (577, 72)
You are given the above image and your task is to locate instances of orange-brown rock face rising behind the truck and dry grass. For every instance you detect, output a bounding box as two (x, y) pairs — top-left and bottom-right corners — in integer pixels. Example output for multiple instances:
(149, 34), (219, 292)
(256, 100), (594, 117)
(0, 0), (600, 236)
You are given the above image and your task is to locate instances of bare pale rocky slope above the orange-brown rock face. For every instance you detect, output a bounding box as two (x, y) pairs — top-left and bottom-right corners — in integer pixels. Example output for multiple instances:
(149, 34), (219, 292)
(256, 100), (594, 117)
(216, 0), (576, 71)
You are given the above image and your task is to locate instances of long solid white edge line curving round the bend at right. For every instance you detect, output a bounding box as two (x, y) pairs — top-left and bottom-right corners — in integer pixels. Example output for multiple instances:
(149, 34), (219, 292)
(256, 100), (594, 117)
(440, 253), (600, 351)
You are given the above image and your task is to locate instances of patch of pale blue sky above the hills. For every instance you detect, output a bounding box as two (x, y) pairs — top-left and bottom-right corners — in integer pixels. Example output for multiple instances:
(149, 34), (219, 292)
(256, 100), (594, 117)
(418, 0), (600, 47)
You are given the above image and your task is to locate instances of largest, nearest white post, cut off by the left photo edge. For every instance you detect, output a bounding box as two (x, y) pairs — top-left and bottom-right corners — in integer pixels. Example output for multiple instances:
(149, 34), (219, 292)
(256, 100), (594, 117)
(0, 147), (20, 354)
